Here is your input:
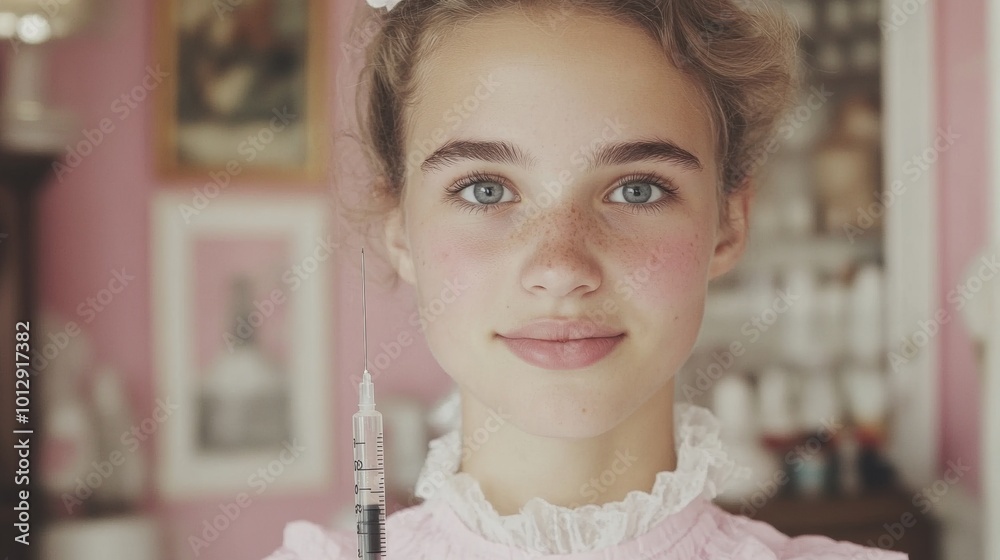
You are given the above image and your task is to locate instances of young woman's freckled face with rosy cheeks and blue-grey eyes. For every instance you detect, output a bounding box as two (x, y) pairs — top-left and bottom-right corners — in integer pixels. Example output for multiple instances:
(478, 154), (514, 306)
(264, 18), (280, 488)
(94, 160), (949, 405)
(386, 7), (749, 437)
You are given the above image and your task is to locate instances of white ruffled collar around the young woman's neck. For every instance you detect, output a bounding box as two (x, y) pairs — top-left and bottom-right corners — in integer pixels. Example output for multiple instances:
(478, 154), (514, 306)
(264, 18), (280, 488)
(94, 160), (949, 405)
(416, 403), (736, 554)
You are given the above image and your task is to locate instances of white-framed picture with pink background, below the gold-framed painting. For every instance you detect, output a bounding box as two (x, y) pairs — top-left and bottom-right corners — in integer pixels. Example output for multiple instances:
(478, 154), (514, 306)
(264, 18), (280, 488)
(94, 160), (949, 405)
(152, 191), (334, 498)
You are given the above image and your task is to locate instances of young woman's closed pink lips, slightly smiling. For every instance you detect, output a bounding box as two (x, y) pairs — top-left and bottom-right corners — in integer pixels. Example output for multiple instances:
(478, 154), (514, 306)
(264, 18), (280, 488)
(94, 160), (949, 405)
(499, 320), (625, 370)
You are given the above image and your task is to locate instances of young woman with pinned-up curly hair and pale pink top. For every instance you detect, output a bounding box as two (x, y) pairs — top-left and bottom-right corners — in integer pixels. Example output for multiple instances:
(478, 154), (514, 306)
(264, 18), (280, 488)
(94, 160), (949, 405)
(271, 0), (905, 560)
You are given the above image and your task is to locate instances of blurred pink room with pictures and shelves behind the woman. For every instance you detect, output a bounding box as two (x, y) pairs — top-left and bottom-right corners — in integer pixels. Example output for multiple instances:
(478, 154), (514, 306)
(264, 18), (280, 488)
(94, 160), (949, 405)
(0, 0), (1000, 560)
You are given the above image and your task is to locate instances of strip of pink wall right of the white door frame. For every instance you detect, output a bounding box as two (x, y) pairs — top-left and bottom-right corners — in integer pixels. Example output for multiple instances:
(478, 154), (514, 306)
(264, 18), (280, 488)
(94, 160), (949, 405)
(933, 0), (989, 494)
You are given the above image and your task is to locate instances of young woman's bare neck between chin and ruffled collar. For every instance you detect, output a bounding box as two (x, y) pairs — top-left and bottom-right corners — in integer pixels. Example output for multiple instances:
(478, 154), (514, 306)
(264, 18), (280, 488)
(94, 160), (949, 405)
(460, 383), (677, 515)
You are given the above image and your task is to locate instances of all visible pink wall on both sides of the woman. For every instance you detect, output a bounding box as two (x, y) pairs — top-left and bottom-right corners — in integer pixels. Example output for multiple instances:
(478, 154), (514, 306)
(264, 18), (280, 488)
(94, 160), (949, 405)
(40, 0), (986, 560)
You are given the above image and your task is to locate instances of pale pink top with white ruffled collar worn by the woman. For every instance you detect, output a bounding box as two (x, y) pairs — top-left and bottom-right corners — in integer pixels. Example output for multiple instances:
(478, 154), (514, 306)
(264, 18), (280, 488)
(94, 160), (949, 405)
(266, 403), (907, 560)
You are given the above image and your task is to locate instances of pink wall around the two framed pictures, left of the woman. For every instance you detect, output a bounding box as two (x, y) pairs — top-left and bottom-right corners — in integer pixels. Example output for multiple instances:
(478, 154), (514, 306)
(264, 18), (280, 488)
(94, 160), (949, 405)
(39, 1), (448, 560)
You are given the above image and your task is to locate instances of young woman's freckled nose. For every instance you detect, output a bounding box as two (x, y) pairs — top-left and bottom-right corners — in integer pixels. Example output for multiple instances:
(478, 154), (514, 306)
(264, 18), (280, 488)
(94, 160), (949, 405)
(521, 203), (601, 298)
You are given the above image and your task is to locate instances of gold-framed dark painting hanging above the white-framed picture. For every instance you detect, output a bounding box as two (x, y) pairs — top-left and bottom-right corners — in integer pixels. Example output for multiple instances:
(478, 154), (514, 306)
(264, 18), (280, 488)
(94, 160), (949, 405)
(154, 0), (328, 182)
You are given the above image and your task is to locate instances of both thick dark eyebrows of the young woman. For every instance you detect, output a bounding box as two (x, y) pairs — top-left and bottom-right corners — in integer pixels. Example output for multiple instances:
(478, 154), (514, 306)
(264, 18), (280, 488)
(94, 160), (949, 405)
(420, 138), (703, 173)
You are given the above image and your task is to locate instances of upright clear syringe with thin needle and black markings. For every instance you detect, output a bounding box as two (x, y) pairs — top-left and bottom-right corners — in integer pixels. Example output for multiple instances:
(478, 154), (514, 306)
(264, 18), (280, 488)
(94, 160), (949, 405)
(353, 249), (385, 560)
